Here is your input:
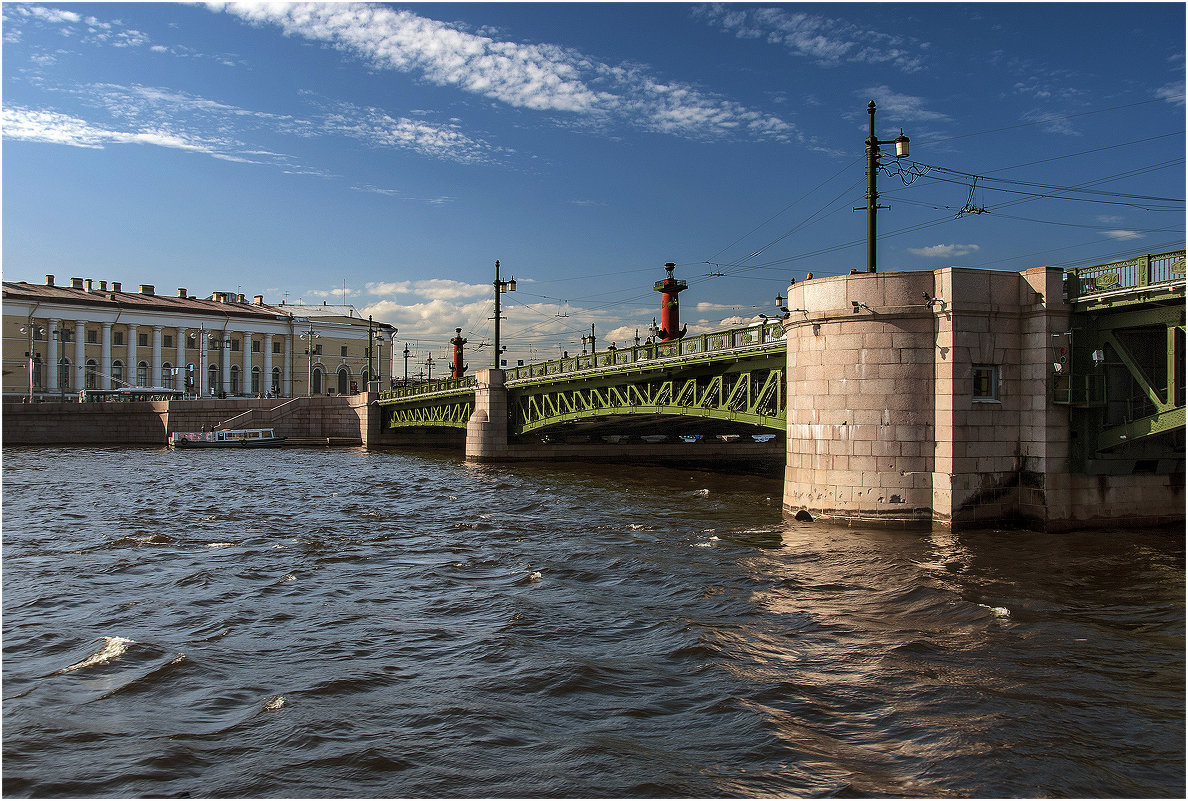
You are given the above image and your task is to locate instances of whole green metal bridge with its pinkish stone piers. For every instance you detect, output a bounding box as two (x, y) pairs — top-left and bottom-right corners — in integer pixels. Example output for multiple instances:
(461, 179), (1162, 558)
(377, 250), (1186, 529)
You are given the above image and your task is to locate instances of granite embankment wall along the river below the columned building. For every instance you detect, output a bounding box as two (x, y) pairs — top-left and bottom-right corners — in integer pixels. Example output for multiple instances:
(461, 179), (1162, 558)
(2, 395), (378, 446)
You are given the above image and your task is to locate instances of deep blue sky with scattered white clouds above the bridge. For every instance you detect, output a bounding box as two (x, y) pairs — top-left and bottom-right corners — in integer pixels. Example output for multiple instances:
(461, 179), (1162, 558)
(2, 2), (1184, 366)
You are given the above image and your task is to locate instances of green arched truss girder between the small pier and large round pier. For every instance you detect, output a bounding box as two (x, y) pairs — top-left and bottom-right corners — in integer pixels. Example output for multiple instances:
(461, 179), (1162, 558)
(508, 352), (788, 435)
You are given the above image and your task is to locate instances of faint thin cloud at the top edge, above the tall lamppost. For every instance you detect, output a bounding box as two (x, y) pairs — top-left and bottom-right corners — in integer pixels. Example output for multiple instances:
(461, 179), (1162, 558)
(693, 4), (929, 72)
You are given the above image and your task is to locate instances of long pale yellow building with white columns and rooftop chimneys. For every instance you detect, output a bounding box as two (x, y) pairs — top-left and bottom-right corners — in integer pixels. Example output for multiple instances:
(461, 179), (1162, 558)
(2, 276), (397, 401)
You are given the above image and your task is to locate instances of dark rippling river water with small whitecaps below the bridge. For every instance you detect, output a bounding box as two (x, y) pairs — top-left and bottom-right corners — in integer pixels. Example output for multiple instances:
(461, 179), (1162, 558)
(2, 448), (1184, 797)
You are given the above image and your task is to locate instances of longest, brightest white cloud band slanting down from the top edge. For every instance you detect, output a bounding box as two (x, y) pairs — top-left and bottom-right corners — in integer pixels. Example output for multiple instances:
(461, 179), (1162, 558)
(208, 2), (796, 140)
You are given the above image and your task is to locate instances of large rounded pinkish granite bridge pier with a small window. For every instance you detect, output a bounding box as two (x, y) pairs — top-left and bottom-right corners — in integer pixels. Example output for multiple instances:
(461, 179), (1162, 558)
(784, 267), (1183, 529)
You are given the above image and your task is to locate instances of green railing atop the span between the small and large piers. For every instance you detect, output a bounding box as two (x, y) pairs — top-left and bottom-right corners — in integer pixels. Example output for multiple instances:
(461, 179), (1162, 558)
(505, 320), (784, 381)
